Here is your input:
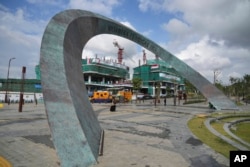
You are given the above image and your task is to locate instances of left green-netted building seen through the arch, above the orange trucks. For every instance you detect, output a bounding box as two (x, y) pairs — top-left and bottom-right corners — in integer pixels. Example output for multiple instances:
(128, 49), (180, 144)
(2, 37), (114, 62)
(35, 57), (132, 92)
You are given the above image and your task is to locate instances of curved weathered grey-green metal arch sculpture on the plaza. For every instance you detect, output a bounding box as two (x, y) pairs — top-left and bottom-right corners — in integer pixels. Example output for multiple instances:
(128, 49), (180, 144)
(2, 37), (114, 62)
(40, 10), (236, 167)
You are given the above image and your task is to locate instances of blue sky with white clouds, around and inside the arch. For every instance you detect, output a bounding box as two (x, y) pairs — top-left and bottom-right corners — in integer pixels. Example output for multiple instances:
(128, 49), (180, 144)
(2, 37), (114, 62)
(0, 0), (250, 85)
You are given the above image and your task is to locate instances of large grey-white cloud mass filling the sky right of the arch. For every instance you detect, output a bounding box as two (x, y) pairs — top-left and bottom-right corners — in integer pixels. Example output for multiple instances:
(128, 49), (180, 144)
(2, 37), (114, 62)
(139, 0), (250, 83)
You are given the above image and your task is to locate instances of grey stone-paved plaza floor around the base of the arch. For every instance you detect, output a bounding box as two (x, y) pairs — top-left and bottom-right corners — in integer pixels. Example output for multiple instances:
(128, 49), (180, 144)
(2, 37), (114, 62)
(0, 100), (248, 167)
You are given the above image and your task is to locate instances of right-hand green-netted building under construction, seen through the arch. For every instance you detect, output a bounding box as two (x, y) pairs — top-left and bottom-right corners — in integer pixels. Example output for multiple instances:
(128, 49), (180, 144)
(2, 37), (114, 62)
(133, 57), (185, 96)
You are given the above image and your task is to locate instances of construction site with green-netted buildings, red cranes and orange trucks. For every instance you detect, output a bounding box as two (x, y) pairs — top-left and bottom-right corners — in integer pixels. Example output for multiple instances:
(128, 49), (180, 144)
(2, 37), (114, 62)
(0, 40), (185, 103)
